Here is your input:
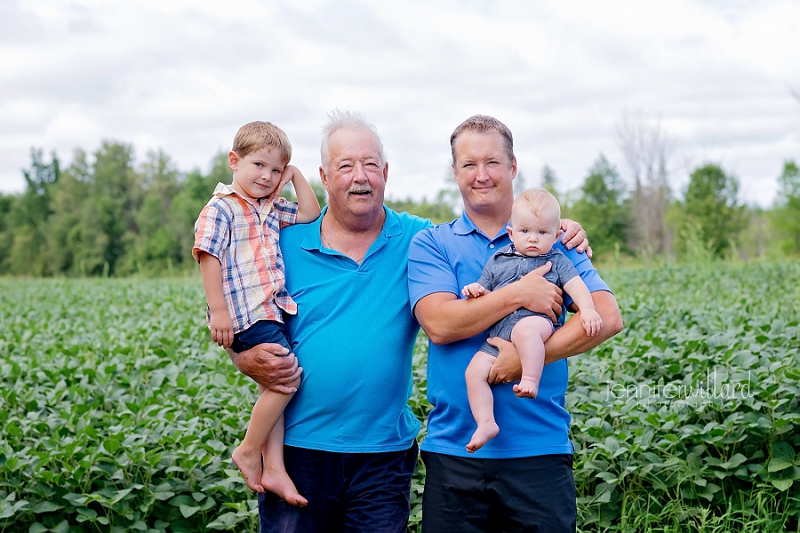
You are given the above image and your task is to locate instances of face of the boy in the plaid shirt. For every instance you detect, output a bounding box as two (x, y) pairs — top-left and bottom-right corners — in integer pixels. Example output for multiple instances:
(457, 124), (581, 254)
(228, 146), (286, 199)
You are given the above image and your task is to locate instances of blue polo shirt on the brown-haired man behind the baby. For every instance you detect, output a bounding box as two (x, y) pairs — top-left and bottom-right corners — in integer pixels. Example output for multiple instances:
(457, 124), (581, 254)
(408, 213), (609, 459)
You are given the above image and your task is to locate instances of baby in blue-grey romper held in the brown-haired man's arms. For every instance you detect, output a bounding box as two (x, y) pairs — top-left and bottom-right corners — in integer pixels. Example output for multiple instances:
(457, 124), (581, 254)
(461, 188), (602, 453)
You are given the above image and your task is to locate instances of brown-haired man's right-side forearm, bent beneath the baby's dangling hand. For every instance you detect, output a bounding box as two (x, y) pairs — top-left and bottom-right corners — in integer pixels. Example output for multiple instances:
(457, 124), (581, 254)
(544, 291), (622, 364)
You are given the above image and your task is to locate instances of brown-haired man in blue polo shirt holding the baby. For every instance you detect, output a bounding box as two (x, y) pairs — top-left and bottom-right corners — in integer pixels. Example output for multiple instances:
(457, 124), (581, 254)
(409, 115), (622, 533)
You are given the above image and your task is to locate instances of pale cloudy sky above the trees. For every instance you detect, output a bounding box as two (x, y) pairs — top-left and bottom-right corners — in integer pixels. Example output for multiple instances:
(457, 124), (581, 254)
(0, 0), (800, 206)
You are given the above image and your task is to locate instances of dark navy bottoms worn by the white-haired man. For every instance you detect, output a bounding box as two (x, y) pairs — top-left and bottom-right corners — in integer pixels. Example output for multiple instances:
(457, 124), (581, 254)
(258, 440), (418, 533)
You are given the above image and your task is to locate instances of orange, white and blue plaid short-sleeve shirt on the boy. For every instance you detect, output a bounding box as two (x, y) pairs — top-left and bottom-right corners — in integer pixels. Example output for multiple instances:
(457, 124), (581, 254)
(192, 183), (297, 333)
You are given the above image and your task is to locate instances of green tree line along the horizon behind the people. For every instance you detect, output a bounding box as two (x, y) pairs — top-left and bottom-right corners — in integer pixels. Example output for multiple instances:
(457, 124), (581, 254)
(0, 139), (800, 276)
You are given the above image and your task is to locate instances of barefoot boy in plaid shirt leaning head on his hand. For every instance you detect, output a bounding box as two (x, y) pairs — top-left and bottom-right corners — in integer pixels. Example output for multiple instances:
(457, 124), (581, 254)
(192, 122), (320, 507)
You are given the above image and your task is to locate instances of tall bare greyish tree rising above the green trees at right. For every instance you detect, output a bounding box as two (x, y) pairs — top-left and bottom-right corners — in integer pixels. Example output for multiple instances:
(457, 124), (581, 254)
(617, 114), (671, 257)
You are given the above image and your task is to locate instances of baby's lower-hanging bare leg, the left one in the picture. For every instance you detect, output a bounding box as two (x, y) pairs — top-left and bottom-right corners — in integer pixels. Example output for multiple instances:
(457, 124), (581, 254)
(465, 352), (500, 453)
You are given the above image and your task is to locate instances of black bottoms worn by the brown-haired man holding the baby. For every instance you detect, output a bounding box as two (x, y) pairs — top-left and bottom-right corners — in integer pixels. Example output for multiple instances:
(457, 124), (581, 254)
(422, 452), (578, 533)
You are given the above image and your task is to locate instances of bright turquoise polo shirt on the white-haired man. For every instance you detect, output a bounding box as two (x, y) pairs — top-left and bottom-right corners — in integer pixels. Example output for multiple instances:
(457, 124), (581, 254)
(281, 207), (431, 453)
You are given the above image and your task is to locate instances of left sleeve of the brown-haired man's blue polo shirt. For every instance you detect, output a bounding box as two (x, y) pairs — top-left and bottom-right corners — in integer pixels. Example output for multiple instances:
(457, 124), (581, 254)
(408, 228), (461, 311)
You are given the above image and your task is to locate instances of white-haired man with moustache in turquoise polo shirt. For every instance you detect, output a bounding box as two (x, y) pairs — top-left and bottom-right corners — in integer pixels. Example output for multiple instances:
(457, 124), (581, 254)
(235, 112), (431, 533)
